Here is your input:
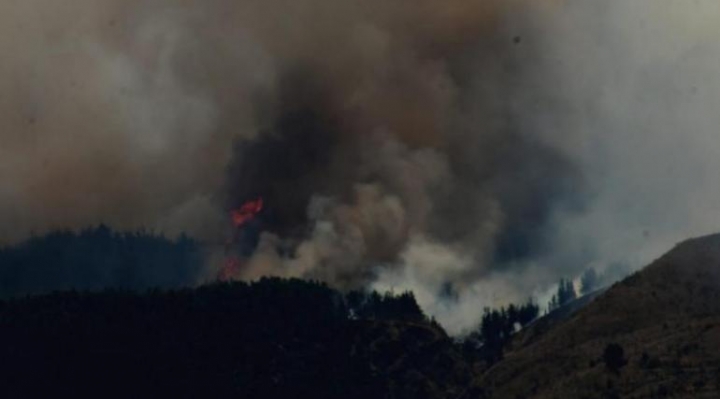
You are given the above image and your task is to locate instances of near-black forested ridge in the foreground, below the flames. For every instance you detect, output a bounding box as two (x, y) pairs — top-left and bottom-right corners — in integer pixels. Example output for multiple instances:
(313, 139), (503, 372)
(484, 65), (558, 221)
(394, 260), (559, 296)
(0, 279), (471, 398)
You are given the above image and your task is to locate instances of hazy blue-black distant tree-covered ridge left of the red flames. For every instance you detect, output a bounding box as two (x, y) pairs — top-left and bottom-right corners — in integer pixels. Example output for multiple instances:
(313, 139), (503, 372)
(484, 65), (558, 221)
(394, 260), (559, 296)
(0, 226), (203, 298)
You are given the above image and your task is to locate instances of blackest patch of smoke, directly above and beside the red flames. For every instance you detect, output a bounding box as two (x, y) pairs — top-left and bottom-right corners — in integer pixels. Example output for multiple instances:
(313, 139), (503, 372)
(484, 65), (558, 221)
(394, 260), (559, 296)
(226, 73), (342, 236)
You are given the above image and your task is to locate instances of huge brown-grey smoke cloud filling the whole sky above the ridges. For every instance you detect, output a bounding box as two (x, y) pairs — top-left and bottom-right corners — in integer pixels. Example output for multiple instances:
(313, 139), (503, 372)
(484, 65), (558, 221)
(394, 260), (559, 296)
(0, 0), (720, 332)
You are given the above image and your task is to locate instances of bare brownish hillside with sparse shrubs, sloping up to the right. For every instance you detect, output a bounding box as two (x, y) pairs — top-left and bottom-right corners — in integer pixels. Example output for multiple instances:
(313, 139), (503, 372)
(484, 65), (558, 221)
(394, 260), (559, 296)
(476, 235), (720, 399)
